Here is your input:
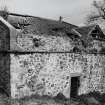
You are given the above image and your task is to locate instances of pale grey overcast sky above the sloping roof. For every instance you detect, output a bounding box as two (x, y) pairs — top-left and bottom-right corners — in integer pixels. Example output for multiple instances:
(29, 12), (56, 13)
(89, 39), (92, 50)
(0, 0), (100, 25)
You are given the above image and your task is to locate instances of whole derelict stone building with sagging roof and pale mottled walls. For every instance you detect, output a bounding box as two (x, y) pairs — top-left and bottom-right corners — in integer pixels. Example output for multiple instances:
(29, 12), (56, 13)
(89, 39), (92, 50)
(0, 14), (105, 98)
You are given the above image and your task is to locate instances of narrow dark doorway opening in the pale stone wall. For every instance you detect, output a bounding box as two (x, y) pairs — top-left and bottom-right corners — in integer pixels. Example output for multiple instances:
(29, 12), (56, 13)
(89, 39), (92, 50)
(70, 76), (80, 98)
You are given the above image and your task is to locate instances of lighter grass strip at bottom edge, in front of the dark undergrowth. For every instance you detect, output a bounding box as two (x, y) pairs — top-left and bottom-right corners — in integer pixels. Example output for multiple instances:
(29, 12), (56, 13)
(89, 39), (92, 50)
(0, 96), (84, 105)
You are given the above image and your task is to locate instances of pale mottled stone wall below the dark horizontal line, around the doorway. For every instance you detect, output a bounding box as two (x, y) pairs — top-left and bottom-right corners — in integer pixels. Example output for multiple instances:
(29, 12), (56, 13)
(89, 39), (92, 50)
(10, 53), (105, 98)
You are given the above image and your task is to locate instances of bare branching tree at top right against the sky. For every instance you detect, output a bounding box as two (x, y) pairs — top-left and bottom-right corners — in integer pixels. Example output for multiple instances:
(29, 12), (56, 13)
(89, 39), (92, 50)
(87, 0), (105, 23)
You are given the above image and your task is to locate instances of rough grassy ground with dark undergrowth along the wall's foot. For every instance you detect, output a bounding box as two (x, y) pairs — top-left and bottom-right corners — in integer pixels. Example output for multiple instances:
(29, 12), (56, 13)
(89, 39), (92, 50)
(0, 93), (105, 105)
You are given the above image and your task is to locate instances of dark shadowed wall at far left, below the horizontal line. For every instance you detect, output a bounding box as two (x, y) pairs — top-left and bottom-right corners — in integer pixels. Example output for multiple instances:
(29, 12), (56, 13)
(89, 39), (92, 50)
(0, 53), (11, 97)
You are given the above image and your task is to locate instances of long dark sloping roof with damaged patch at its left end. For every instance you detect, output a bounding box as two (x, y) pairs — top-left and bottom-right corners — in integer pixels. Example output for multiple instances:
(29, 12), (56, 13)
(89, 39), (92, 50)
(8, 14), (77, 34)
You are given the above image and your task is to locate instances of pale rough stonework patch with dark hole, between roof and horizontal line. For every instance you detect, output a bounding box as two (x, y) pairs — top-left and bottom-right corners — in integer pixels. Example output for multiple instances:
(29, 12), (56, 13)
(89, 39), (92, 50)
(17, 33), (74, 52)
